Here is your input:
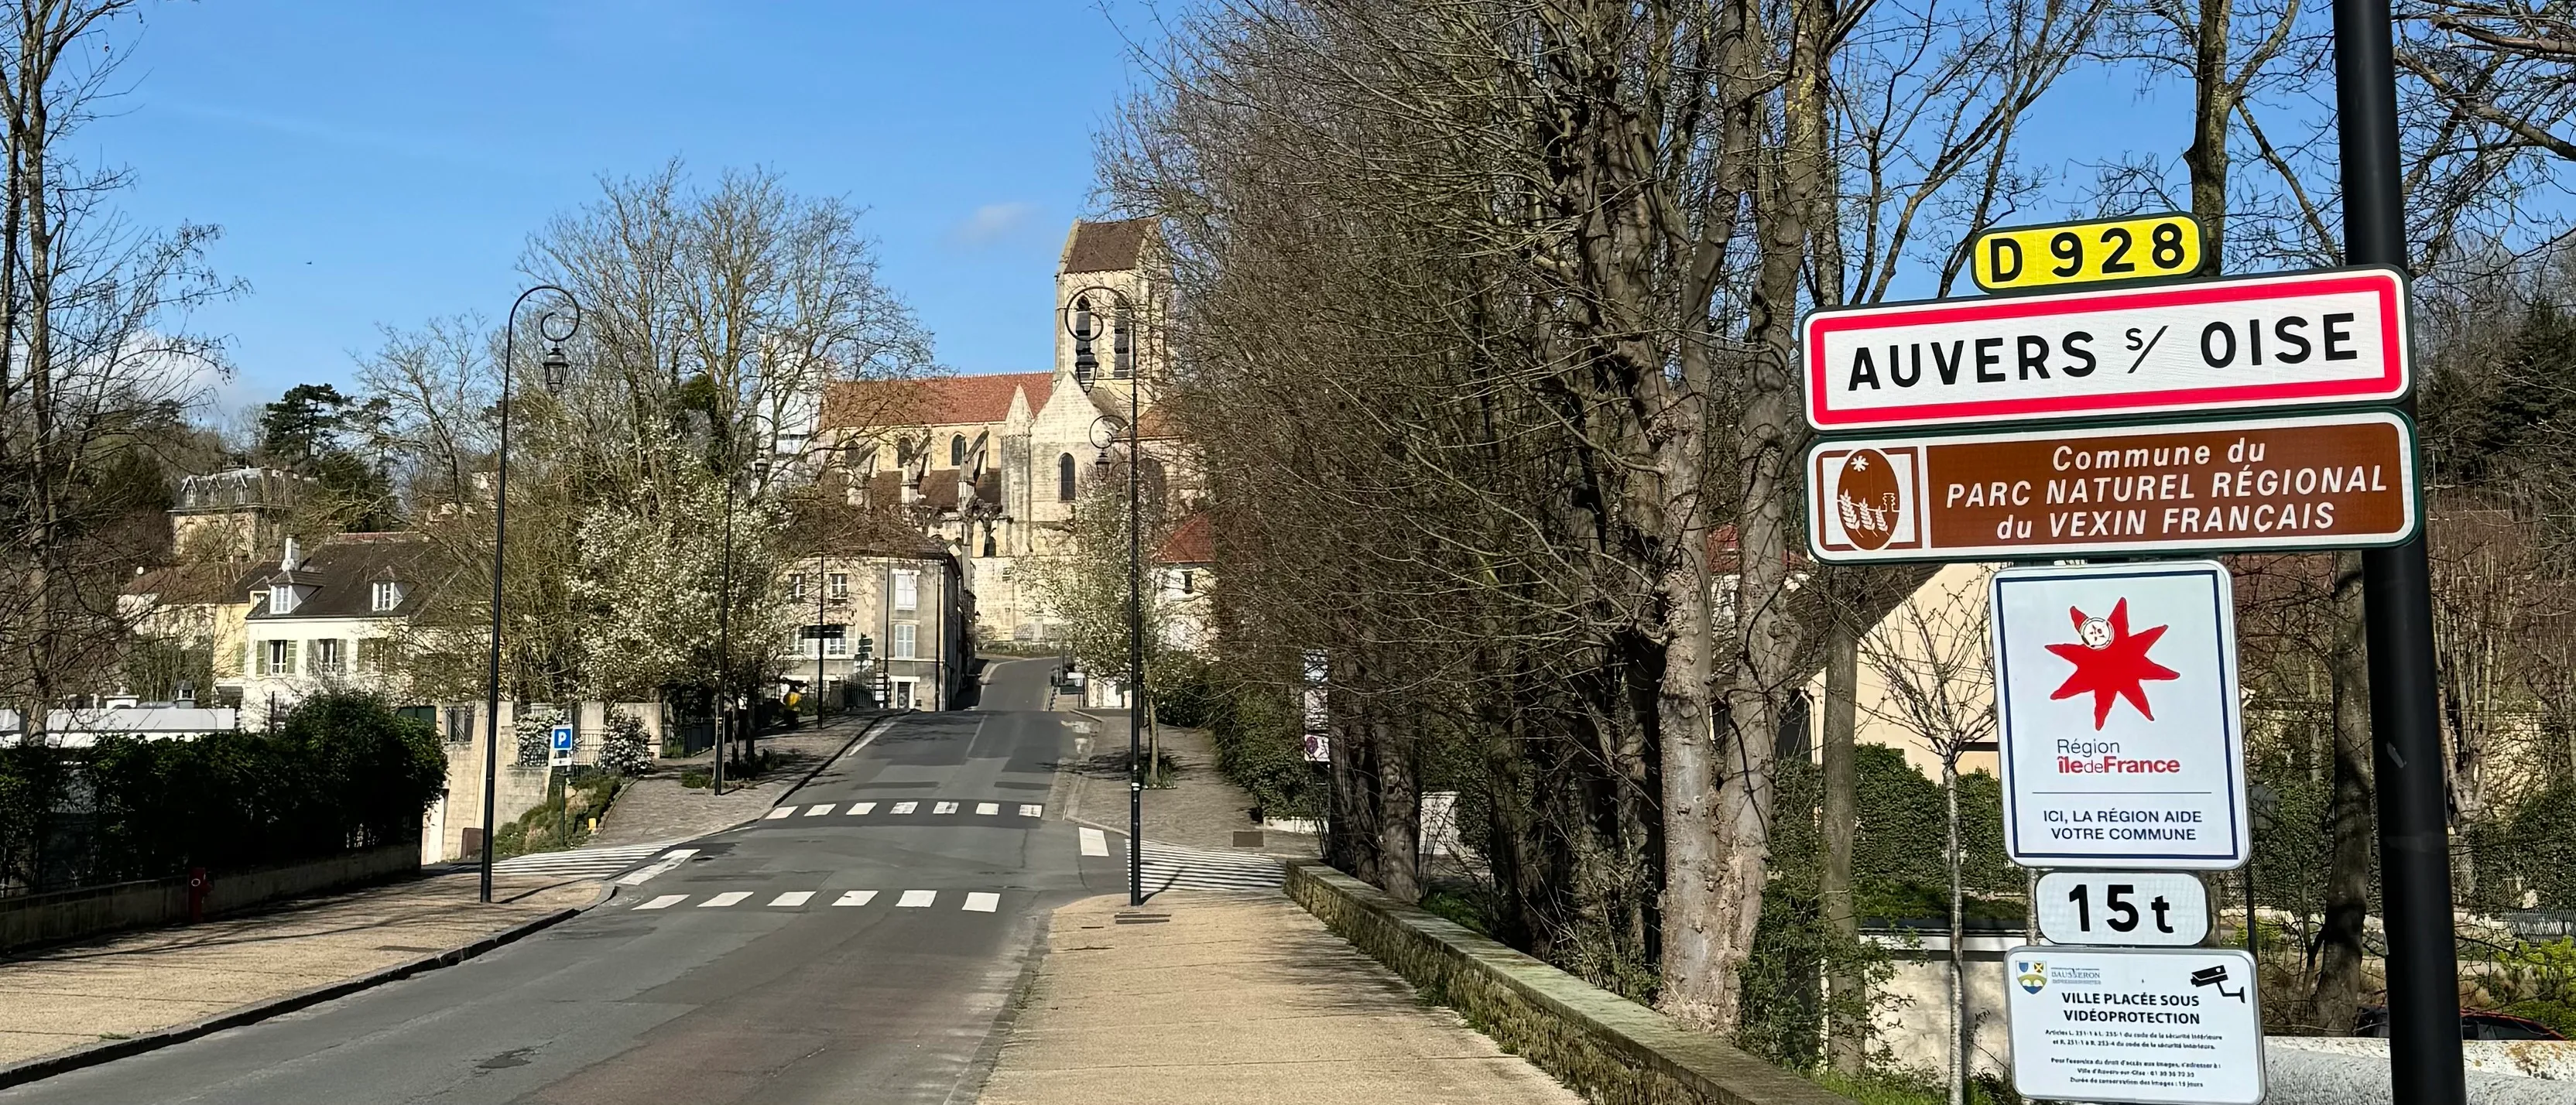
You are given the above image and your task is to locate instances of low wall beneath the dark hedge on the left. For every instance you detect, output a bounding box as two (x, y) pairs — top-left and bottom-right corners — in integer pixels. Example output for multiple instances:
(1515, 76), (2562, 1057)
(0, 842), (420, 948)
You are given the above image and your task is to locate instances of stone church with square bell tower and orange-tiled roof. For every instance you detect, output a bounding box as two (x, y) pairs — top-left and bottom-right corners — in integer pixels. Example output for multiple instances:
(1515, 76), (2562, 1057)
(817, 219), (1198, 644)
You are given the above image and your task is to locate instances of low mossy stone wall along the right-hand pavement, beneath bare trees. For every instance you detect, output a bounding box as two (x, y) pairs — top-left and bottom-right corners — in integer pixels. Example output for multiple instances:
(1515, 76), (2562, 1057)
(1288, 863), (1852, 1105)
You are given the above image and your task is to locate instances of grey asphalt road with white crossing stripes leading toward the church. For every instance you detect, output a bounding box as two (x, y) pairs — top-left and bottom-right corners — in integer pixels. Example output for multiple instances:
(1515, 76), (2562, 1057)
(0, 662), (1121, 1105)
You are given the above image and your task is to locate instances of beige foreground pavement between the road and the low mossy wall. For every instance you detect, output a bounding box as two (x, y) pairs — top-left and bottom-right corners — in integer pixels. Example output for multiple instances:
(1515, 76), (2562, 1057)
(981, 891), (1581, 1105)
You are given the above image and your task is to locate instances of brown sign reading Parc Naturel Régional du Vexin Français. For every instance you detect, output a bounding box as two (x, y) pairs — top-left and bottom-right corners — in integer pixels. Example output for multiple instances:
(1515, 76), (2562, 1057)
(1806, 409), (2417, 562)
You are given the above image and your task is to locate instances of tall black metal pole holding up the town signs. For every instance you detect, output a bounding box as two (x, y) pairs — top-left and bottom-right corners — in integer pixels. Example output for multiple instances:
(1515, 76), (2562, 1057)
(2334, 0), (2468, 1105)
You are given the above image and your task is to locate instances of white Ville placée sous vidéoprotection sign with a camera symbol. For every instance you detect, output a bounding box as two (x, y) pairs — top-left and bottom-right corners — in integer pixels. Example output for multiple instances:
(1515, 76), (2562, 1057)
(2004, 946), (2264, 1105)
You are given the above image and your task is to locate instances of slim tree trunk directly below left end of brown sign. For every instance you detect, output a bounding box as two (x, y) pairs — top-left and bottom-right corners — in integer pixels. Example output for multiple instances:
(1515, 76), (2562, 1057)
(1816, 611), (1870, 1074)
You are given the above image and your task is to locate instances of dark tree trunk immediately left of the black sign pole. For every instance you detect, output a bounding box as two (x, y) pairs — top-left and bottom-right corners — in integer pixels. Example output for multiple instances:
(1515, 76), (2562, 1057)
(2311, 551), (2378, 1035)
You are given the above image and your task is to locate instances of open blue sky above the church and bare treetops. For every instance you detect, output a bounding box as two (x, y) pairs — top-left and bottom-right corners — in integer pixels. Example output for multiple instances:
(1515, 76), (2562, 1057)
(91, 0), (1152, 407)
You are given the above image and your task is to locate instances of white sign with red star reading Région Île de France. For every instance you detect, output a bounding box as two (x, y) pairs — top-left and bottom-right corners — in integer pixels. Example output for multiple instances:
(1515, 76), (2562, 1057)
(1992, 562), (2249, 871)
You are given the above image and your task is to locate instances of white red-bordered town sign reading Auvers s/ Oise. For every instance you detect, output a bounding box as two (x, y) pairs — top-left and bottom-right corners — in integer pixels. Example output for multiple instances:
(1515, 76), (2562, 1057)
(1804, 268), (2413, 433)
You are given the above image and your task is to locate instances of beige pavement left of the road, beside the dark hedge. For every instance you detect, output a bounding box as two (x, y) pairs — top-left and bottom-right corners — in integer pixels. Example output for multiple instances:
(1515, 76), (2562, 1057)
(0, 871), (600, 1084)
